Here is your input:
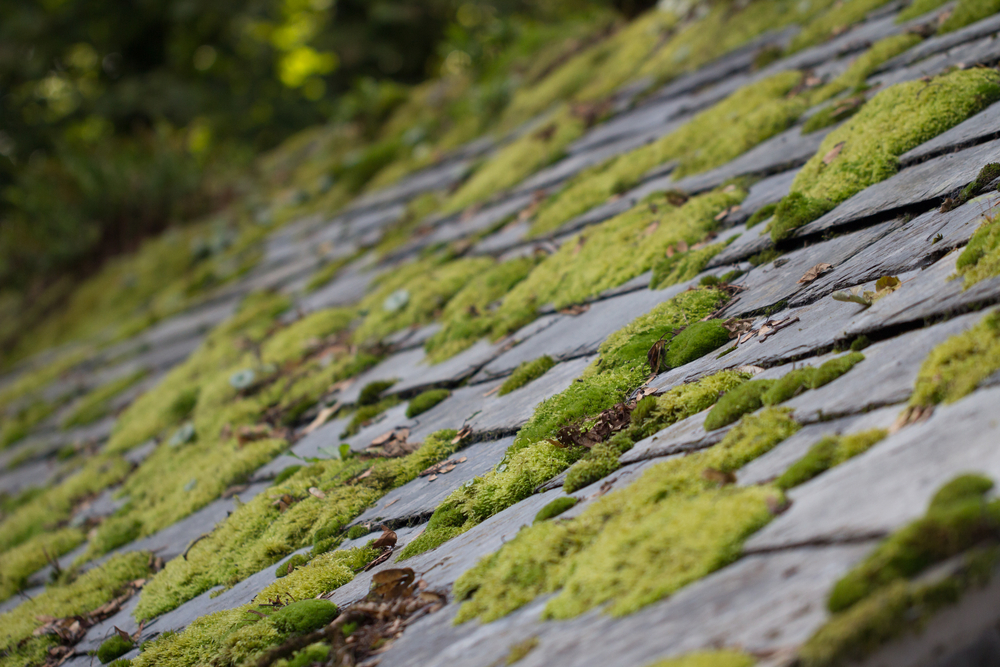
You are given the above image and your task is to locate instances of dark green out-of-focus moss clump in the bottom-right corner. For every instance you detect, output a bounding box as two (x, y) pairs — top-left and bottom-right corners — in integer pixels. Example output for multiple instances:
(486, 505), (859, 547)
(799, 475), (1000, 667)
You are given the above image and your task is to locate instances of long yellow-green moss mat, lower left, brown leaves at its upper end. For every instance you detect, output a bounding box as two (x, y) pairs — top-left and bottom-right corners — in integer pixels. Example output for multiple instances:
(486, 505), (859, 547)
(135, 430), (457, 619)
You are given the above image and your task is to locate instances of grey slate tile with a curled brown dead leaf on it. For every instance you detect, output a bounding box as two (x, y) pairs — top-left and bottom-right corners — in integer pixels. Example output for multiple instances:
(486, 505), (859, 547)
(724, 220), (904, 315)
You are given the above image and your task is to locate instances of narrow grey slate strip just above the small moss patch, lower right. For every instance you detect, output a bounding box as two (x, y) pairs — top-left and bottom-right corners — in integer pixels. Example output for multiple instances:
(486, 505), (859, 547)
(736, 405), (904, 486)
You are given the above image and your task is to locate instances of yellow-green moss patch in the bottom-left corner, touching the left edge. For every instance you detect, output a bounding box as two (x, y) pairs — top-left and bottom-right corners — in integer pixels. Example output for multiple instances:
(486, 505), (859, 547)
(0, 551), (149, 662)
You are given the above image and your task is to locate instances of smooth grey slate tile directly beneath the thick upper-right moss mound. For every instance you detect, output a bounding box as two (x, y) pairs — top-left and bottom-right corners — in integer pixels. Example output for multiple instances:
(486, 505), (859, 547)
(795, 140), (1000, 238)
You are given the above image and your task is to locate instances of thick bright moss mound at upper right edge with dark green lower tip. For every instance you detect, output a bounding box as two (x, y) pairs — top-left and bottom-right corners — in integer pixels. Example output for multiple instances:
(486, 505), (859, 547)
(770, 70), (1000, 242)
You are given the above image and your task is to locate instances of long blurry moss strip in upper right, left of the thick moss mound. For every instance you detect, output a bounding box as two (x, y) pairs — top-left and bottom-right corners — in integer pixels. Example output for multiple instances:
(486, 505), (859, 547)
(531, 72), (808, 235)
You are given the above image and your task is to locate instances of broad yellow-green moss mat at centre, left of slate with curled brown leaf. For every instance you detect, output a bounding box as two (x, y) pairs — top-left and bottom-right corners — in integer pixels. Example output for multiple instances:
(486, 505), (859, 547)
(493, 188), (745, 344)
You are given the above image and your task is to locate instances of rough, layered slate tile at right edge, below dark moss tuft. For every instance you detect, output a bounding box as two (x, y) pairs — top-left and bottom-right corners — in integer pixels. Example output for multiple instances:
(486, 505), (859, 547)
(789, 193), (1000, 306)
